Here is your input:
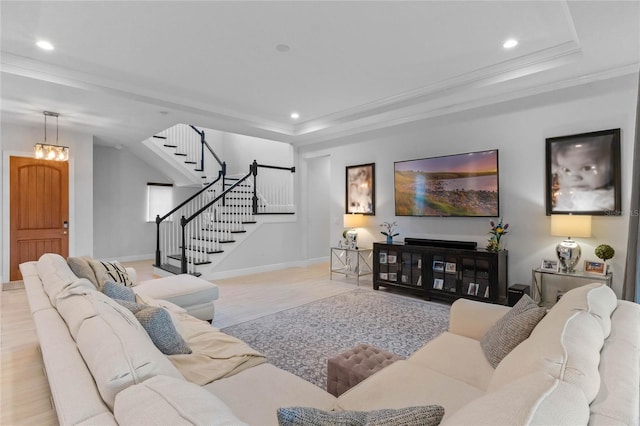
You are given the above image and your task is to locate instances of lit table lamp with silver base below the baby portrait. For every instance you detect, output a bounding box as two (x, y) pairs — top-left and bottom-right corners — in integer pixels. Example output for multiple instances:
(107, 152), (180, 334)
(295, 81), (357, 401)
(551, 214), (591, 272)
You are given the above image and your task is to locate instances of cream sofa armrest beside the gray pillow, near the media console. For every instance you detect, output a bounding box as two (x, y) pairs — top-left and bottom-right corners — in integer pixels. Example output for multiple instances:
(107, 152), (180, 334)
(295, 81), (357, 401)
(449, 299), (511, 340)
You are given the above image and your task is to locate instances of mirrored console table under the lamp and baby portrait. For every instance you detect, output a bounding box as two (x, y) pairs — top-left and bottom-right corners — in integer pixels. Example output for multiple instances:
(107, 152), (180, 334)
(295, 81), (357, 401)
(531, 268), (613, 308)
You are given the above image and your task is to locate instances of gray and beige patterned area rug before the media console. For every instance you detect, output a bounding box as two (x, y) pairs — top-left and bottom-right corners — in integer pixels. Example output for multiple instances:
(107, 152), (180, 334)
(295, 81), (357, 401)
(222, 290), (449, 389)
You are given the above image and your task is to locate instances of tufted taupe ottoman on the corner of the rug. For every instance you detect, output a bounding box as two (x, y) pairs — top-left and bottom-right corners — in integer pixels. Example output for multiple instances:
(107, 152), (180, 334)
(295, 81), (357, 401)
(327, 343), (404, 396)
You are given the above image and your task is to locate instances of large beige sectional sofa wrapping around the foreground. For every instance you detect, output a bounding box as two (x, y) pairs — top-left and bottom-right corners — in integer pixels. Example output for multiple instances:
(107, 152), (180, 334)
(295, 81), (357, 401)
(20, 254), (640, 425)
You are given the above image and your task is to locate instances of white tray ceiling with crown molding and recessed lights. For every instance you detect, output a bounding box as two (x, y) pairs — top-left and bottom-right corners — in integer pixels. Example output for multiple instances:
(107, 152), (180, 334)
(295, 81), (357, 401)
(0, 1), (640, 146)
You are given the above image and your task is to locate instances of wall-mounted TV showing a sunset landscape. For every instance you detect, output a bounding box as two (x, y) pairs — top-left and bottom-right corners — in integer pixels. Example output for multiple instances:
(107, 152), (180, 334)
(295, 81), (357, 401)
(394, 149), (500, 217)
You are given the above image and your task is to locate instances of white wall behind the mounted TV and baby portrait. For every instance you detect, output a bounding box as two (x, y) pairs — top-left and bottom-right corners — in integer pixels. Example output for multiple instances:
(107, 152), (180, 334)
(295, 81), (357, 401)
(299, 75), (638, 295)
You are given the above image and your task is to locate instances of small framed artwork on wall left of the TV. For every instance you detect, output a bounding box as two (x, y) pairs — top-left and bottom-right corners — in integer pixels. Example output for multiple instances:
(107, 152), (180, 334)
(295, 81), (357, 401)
(345, 163), (376, 215)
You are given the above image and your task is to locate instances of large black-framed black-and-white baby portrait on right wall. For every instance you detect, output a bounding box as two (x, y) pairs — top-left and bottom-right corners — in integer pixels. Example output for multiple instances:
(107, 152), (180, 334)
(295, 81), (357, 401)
(546, 129), (621, 216)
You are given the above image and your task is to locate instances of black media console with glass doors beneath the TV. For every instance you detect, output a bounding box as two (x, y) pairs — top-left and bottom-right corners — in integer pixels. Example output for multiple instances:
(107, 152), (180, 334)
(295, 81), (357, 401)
(373, 239), (508, 305)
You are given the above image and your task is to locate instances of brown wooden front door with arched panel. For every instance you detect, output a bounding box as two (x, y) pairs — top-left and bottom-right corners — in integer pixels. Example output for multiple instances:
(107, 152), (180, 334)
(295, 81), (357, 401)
(9, 157), (69, 281)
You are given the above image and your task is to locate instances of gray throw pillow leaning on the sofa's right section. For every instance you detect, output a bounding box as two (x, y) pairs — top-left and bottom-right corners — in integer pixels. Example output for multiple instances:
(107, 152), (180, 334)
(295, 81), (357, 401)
(480, 294), (547, 368)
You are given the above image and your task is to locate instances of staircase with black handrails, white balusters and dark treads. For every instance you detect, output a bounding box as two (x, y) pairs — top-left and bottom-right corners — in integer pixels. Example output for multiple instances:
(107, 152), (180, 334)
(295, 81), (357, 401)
(152, 125), (295, 276)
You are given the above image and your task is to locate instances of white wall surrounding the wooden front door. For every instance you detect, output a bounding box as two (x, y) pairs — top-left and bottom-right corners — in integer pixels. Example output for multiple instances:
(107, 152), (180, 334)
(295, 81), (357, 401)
(0, 119), (93, 282)
